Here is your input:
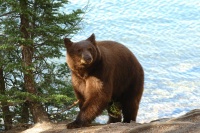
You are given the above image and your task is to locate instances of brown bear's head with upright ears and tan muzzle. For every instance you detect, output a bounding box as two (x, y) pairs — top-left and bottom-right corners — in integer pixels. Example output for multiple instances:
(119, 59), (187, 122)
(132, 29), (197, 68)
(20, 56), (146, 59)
(64, 34), (100, 70)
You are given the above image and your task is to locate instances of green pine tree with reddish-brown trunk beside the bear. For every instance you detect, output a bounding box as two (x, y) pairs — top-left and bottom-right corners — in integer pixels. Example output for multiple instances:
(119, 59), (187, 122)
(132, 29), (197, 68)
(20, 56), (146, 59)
(0, 0), (83, 129)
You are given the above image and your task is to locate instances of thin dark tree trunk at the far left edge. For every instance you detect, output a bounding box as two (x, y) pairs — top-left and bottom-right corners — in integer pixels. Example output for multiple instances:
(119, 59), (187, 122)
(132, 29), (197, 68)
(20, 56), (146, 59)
(0, 68), (12, 130)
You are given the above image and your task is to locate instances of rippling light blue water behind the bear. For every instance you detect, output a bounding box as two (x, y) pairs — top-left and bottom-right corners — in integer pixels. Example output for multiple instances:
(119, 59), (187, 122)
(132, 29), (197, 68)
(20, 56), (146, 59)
(63, 0), (200, 122)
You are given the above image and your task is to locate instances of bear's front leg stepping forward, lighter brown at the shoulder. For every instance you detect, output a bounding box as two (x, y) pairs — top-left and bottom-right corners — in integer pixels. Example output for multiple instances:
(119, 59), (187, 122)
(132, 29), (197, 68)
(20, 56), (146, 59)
(67, 77), (110, 129)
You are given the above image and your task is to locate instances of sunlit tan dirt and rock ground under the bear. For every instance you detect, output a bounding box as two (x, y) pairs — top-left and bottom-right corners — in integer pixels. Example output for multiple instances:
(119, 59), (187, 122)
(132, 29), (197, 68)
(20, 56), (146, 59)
(5, 109), (200, 133)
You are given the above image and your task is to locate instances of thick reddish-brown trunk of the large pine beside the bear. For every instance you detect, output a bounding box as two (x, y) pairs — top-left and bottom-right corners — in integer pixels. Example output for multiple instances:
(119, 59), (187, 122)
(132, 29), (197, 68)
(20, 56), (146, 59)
(20, 0), (49, 123)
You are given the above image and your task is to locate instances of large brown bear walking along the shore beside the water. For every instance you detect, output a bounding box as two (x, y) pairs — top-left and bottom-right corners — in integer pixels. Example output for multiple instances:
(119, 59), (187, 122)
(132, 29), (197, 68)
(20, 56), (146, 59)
(64, 33), (144, 129)
